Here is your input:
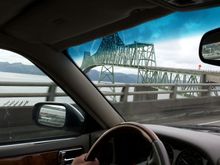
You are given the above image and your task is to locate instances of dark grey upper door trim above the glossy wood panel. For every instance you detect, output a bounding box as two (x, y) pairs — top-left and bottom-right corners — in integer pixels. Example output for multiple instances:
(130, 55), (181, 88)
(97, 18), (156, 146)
(0, 134), (90, 157)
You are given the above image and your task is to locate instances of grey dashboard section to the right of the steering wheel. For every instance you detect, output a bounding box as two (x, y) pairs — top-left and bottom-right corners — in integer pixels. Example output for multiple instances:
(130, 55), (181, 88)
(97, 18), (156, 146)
(145, 125), (220, 165)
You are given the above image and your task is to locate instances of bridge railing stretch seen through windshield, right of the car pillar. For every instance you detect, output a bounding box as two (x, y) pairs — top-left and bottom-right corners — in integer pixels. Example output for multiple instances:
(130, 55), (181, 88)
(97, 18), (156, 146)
(97, 83), (220, 102)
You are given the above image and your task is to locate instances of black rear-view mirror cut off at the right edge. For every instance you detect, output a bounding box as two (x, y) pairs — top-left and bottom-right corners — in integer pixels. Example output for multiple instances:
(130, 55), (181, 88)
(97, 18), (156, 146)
(199, 28), (220, 66)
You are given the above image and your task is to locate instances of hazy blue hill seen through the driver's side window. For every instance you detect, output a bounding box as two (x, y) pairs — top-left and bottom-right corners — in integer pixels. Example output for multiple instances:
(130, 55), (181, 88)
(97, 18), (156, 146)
(0, 62), (44, 75)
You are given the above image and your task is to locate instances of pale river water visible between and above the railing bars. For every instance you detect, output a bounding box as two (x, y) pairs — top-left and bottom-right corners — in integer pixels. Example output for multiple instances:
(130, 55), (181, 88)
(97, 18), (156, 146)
(0, 72), (186, 106)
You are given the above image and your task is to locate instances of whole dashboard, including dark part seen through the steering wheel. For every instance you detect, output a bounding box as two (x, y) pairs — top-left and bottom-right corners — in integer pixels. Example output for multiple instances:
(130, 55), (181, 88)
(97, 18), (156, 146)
(90, 124), (220, 165)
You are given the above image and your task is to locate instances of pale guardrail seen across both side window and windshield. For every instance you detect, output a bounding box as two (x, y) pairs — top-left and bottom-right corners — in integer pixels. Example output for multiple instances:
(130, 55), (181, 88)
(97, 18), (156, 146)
(0, 82), (220, 106)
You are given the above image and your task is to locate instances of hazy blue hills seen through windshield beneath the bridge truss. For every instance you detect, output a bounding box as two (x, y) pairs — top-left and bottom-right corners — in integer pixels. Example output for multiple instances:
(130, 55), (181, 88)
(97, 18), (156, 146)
(87, 70), (137, 83)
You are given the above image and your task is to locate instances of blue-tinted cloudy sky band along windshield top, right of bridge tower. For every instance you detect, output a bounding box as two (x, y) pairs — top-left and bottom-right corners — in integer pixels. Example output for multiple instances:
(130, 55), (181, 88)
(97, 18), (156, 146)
(119, 7), (220, 43)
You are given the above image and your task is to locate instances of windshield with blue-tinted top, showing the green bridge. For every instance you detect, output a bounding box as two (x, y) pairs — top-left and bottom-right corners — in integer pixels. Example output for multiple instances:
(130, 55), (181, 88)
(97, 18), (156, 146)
(67, 8), (220, 126)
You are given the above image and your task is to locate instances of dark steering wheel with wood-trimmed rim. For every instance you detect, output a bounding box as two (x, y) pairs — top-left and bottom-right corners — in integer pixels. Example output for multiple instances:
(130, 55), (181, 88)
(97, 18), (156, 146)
(86, 122), (170, 165)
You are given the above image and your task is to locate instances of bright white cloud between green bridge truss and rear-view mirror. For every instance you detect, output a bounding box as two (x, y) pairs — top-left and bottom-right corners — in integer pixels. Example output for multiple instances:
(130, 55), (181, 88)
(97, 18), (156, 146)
(155, 36), (220, 71)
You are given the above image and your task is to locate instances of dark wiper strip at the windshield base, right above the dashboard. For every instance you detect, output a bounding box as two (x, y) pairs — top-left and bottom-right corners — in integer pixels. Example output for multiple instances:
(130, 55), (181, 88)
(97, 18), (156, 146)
(167, 124), (220, 133)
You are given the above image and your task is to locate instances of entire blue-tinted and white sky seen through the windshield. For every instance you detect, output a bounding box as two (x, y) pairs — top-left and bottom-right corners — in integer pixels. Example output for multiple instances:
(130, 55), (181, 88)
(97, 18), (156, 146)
(68, 7), (220, 71)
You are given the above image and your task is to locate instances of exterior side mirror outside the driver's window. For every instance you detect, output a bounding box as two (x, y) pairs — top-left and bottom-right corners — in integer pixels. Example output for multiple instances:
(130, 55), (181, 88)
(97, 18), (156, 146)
(33, 102), (85, 131)
